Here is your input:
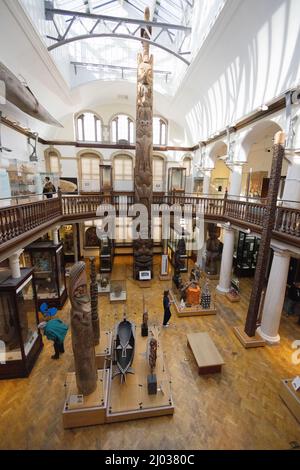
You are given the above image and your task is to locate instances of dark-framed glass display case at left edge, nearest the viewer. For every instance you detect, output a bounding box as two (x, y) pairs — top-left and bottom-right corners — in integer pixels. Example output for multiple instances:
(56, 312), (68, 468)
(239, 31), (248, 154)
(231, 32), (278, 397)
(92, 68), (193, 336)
(0, 268), (43, 379)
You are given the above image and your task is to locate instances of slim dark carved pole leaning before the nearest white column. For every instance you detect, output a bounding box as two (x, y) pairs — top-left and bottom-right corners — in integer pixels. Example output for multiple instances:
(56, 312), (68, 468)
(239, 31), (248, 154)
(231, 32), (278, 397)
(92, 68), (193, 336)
(245, 131), (285, 336)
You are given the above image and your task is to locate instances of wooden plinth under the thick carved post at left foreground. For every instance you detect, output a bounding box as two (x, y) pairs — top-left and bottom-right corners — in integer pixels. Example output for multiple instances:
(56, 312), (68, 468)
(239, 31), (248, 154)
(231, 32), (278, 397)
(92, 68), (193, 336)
(62, 369), (109, 429)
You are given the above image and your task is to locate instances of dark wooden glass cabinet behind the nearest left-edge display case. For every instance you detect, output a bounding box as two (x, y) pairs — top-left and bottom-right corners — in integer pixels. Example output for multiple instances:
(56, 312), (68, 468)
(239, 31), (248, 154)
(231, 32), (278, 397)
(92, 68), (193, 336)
(26, 241), (67, 308)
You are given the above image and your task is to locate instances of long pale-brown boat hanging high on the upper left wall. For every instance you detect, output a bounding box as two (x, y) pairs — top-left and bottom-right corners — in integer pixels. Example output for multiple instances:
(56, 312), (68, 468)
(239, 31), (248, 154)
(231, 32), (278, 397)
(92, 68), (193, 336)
(0, 62), (63, 127)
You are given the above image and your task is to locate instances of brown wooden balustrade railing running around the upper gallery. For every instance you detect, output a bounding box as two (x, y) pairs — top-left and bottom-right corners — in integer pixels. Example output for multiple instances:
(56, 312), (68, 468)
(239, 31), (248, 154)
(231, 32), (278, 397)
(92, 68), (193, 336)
(0, 193), (300, 251)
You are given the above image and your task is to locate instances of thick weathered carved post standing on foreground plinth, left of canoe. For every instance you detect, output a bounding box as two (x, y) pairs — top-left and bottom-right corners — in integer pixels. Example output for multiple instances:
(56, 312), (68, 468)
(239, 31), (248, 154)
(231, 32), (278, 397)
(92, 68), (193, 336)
(69, 261), (97, 395)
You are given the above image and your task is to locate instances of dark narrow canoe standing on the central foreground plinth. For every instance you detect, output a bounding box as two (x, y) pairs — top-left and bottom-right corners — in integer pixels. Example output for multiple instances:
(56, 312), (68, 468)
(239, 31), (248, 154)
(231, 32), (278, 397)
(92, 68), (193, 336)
(114, 318), (135, 380)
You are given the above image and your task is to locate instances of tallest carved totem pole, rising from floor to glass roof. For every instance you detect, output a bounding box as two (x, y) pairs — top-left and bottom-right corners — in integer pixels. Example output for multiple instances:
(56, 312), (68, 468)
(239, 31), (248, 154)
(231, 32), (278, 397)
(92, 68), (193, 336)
(133, 7), (153, 279)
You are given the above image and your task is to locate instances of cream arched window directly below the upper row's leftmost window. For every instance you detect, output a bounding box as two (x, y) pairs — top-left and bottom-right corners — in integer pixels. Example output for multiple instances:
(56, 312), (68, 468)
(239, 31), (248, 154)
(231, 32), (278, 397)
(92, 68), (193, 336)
(79, 152), (101, 191)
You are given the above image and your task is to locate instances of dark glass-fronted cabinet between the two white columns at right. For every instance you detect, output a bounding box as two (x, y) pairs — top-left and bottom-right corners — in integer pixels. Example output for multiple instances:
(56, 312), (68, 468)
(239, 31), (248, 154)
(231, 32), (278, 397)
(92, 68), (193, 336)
(234, 232), (260, 277)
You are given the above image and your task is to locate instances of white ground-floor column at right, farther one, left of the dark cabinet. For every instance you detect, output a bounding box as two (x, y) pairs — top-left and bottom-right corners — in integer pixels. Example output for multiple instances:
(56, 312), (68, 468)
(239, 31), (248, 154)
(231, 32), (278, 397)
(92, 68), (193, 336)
(217, 224), (234, 294)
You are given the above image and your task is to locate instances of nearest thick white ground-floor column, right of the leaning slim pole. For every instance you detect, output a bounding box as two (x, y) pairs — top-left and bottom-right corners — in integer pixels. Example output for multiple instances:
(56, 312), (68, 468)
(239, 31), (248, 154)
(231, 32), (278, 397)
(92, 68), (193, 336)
(257, 250), (290, 344)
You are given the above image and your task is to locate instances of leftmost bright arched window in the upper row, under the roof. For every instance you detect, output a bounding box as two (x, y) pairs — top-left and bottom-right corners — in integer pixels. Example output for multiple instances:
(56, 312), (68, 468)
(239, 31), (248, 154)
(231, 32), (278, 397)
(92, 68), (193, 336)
(75, 111), (102, 142)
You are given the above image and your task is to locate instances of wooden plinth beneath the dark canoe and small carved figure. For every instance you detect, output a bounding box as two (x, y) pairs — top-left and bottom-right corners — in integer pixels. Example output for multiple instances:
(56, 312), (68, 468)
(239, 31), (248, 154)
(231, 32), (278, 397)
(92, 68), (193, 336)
(106, 328), (174, 423)
